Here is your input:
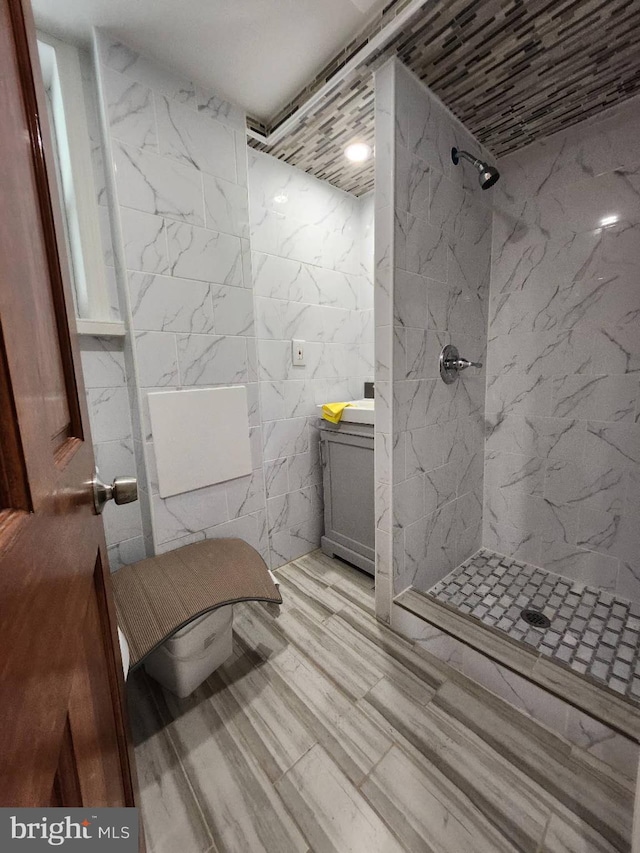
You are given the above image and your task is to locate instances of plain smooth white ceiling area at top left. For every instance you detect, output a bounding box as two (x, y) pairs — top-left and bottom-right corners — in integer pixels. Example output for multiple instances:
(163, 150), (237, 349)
(32, 0), (387, 120)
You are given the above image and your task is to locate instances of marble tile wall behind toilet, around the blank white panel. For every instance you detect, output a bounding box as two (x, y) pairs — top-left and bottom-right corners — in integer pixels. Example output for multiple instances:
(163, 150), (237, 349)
(92, 33), (268, 557)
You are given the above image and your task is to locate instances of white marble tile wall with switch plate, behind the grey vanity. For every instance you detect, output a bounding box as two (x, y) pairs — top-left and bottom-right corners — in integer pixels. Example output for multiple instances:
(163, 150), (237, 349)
(249, 150), (373, 568)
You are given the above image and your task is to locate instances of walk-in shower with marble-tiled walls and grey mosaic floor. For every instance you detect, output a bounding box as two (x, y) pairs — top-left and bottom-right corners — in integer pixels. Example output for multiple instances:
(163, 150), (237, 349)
(375, 59), (640, 712)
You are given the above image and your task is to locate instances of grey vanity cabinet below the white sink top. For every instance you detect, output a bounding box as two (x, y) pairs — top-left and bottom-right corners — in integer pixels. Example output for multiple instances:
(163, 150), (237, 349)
(320, 421), (375, 575)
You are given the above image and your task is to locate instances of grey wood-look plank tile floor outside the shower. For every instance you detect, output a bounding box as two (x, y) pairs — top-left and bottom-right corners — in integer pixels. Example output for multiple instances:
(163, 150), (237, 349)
(129, 552), (633, 853)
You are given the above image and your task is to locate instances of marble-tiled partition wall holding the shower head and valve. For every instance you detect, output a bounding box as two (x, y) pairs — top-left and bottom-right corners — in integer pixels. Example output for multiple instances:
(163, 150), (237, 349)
(376, 61), (491, 604)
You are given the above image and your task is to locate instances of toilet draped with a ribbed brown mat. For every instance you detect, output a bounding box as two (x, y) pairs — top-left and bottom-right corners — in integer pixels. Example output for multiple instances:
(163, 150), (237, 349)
(111, 538), (282, 698)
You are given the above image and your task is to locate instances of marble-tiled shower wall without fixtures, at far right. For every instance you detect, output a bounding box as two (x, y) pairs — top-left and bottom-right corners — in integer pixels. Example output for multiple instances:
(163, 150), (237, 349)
(483, 98), (640, 600)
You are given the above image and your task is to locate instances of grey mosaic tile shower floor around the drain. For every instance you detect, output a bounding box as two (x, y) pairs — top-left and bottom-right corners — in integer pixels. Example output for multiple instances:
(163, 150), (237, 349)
(428, 549), (640, 702)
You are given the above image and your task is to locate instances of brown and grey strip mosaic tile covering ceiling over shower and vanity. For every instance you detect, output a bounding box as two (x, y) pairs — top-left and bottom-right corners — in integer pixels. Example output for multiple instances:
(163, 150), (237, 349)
(249, 0), (640, 195)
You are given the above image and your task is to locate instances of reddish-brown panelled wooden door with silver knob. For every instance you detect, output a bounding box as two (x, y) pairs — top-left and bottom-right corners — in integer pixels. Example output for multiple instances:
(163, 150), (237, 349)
(0, 0), (140, 820)
